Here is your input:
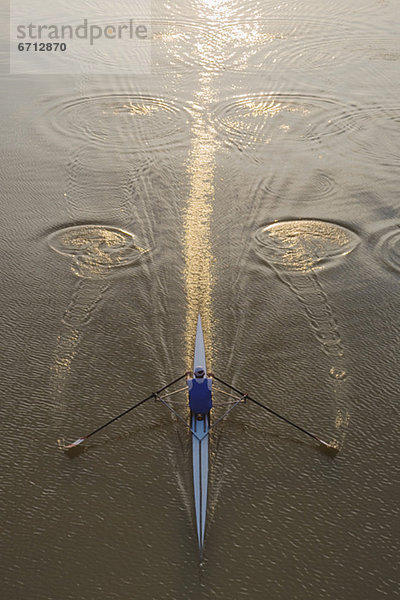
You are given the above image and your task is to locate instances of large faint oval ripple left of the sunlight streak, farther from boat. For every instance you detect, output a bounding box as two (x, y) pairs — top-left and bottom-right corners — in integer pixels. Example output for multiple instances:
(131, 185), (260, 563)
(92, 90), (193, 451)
(46, 94), (189, 153)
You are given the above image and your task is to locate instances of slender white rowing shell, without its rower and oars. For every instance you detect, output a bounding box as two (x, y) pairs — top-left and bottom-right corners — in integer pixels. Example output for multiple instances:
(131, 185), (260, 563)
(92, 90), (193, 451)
(190, 315), (210, 558)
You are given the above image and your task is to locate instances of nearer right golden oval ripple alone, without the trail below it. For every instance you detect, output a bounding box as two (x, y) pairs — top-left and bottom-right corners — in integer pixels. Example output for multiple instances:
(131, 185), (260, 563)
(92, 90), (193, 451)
(255, 219), (360, 271)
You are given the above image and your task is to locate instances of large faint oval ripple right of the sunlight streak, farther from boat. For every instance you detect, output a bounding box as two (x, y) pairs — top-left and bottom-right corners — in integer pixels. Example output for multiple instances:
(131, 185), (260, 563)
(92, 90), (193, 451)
(213, 94), (357, 147)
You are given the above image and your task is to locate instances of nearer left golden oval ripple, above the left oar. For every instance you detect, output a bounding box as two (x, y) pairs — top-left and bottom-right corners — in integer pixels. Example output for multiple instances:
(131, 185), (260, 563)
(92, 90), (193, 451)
(49, 225), (147, 279)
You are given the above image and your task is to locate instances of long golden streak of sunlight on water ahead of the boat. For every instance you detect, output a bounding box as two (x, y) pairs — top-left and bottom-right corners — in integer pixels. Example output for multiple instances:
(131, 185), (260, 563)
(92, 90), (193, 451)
(183, 0), (276, 369)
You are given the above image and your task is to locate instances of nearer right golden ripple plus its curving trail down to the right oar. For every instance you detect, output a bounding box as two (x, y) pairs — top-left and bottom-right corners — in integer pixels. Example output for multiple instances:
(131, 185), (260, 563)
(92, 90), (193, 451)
(255, 219), (359, 440)
